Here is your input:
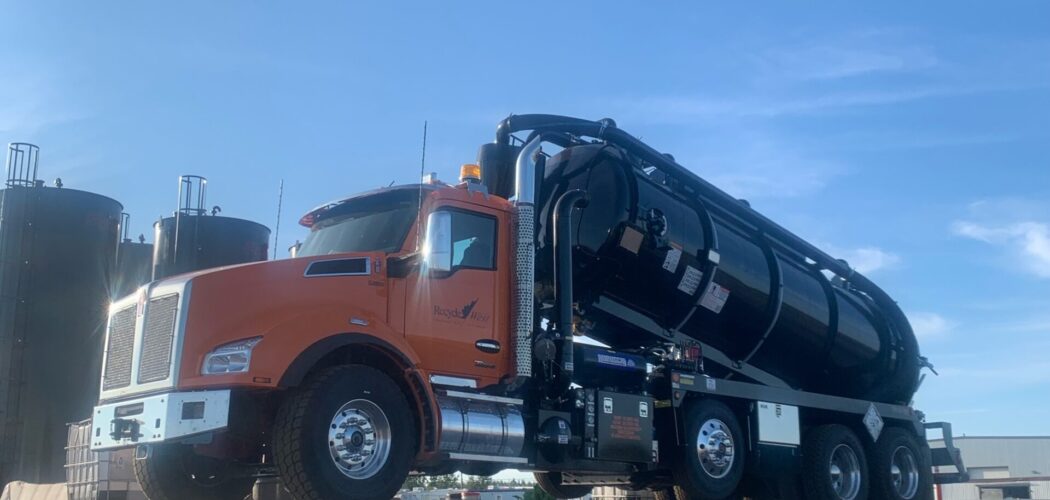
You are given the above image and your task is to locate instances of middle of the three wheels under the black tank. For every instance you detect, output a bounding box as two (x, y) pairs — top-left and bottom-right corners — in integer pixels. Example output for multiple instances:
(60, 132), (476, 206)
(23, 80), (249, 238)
(802, 424), (870, 500)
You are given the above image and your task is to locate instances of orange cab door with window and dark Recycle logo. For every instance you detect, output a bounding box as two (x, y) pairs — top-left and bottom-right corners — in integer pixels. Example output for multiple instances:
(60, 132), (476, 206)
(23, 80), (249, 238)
(405, 206), (503, 387)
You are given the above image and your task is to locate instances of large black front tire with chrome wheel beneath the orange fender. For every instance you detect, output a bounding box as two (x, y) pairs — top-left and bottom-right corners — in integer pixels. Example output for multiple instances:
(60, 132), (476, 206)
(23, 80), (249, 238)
(274, 364), (417, 500)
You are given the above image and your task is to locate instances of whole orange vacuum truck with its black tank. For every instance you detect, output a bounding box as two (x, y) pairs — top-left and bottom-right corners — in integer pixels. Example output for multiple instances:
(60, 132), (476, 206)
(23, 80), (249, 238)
(92, 114), (966, 500)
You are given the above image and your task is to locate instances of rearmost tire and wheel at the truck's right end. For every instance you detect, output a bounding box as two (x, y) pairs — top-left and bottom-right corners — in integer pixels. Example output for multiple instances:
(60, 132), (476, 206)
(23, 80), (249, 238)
(872, 428), (933, 500)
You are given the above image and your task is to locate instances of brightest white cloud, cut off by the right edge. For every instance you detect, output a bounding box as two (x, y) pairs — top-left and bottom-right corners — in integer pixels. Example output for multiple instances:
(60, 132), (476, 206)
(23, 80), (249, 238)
(951, 221), (1050, 278)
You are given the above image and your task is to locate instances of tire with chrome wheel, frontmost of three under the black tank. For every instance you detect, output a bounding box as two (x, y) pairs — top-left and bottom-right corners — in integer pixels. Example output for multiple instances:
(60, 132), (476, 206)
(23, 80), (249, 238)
(671, 399), (747, 500)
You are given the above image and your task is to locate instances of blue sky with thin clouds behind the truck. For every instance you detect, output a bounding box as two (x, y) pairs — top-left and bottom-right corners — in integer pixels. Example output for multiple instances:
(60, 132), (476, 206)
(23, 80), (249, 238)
(0, 0), (1050, 435)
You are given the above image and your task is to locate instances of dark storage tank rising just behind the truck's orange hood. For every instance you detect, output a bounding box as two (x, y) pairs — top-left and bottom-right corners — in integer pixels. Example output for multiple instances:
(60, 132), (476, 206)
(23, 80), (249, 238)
(153, 175), (270, 279)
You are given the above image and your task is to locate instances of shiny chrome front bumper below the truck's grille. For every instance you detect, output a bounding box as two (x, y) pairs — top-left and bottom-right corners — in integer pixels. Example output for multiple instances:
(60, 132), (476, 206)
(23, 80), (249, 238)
(91, 390), (230, 451)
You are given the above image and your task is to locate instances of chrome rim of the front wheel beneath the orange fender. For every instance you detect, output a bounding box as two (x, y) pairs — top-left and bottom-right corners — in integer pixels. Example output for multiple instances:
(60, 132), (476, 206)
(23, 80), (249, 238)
(329, 399), (391, 479)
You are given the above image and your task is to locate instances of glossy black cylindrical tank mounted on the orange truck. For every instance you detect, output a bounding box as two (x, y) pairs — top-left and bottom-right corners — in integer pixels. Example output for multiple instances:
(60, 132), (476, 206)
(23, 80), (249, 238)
(537, 144), (920, 402)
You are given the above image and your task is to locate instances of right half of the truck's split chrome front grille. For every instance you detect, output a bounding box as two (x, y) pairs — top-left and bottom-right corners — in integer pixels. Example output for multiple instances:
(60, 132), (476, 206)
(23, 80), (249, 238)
(139, 293), (179, 383)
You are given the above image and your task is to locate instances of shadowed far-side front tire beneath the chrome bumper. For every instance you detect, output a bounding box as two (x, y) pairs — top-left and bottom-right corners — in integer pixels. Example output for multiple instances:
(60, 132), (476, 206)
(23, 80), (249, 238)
(134, 444), (255, 500)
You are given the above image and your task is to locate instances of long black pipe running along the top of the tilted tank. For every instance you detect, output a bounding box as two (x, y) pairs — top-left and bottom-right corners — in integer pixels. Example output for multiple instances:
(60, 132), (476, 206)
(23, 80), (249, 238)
(496, 114), (919, 403)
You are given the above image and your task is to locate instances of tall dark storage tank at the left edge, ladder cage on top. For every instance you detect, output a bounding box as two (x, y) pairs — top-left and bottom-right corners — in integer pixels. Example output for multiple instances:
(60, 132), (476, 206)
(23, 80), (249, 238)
(0, 143), (121, 484)
